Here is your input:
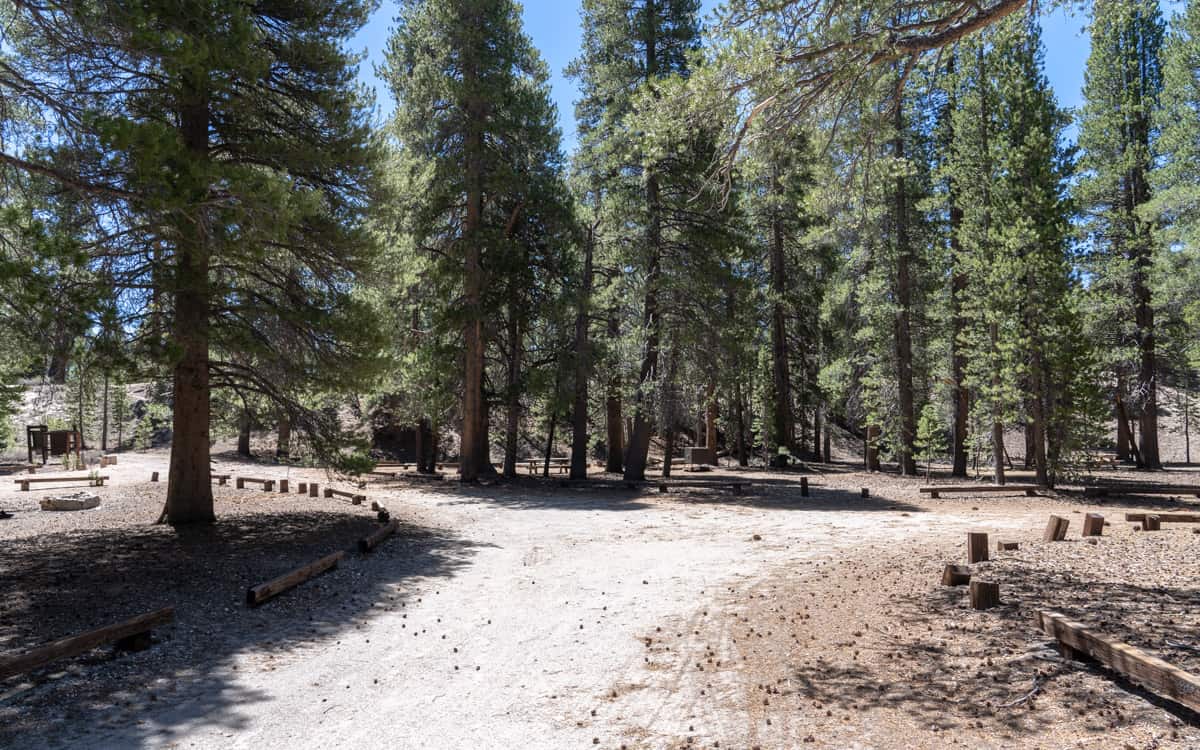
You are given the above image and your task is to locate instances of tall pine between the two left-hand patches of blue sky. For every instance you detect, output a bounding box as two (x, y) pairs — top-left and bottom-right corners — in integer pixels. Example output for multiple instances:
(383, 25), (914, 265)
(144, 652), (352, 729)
(384, 0), (575, 481)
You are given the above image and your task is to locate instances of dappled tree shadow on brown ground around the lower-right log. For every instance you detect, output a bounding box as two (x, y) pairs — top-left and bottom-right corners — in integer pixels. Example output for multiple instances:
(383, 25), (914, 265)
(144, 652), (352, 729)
(782, 562), (1200, 743)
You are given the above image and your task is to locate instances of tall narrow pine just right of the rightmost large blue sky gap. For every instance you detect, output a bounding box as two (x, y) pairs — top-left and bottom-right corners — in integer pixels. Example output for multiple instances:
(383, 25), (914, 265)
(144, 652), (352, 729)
(1075, 0), (1163, 468)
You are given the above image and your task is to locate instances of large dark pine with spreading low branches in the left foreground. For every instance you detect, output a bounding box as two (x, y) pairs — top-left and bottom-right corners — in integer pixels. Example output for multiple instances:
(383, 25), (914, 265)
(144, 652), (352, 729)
(0, 0), (374, 524)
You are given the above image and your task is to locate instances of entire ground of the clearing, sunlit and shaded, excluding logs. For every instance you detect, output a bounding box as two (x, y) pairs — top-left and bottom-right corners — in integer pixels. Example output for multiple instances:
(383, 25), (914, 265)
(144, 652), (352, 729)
(0, 451), (1200, 750)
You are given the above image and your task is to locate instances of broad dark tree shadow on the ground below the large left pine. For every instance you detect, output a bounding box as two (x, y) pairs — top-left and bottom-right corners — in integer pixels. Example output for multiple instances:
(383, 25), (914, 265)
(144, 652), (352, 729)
(0, 511), (484, 746)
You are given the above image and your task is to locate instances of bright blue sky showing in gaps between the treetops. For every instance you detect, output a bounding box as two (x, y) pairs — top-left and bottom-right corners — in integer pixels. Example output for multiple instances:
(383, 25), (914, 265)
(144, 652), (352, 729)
(353, 0), (1182, 152)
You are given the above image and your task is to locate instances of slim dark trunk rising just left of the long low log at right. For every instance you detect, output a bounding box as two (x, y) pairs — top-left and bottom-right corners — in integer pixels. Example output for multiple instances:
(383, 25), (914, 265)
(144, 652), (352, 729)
(894, 106), (917, 476)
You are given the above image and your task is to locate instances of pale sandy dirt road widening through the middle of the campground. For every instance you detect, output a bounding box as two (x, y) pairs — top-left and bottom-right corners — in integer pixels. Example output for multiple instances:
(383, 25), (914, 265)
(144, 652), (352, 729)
(0, 458), (1200, 749)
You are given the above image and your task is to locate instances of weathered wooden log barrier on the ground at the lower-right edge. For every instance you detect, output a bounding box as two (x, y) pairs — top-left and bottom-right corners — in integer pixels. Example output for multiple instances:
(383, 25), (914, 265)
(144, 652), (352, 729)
(1037, 610), (1200, 710)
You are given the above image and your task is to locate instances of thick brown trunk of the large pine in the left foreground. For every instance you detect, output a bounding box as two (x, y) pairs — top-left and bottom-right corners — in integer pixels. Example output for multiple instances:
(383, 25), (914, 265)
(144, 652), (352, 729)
(166, 89), (216, 526)
